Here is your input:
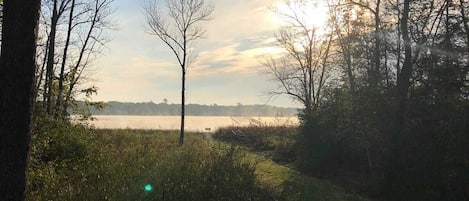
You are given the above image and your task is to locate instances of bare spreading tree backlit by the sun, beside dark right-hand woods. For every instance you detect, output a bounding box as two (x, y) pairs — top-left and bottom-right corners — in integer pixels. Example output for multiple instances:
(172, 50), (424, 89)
(264, 0), (332, 116)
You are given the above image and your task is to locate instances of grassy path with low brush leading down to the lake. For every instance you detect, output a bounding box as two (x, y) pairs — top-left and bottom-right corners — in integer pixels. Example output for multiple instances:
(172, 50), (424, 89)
(214, 125), (368, 201)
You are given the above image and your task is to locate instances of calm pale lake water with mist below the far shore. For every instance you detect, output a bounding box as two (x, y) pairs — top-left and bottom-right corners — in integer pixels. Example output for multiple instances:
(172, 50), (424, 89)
(90, 115), (298, 132)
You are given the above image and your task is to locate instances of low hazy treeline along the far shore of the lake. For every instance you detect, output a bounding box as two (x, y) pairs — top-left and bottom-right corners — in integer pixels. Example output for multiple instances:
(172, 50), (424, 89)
(89, 101), (298, 116)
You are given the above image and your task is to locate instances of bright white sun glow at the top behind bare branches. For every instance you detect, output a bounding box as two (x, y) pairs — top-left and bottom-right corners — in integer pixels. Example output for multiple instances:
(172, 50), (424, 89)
(271, 0), (329, 29)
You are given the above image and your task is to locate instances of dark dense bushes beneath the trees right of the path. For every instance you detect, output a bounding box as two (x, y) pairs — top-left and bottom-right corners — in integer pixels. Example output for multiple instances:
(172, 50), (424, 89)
(296, 81), (469, 200)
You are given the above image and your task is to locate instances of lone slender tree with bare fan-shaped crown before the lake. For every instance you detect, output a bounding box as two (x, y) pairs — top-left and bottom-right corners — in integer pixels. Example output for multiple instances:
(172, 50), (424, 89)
(144, 0), (213, 145)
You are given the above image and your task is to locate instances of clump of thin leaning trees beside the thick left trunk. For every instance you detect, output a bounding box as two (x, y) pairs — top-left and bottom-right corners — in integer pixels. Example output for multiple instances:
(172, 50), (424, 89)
(36, 0), (113, 119)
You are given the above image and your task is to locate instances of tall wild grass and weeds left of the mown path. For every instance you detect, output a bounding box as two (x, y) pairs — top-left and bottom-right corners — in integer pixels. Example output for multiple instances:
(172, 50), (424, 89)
(27, 119), (274, 201)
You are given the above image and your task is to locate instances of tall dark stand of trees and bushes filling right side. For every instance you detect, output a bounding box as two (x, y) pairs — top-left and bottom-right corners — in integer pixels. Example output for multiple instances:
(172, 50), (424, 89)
(304, 0), (469, 200)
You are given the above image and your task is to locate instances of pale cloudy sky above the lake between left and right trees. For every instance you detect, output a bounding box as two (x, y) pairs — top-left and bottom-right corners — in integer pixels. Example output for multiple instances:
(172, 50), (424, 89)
(92, 0), (306, 107)
